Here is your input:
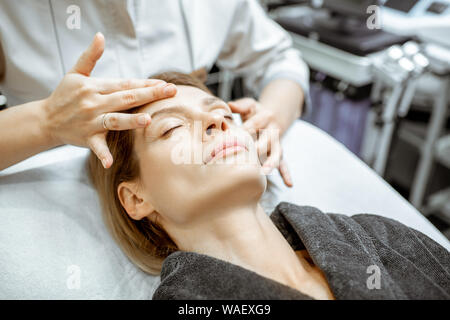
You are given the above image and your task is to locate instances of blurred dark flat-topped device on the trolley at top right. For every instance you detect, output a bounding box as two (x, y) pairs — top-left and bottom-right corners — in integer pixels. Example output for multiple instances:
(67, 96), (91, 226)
(273, 1), (409, 58)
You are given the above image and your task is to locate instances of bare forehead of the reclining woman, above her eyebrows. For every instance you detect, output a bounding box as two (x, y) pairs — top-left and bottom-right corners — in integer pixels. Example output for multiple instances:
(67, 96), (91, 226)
(139, 85), (224, 114)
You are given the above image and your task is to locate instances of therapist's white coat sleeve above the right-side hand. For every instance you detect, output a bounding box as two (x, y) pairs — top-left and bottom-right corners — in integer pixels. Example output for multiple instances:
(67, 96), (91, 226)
(217, 0), (311, 114)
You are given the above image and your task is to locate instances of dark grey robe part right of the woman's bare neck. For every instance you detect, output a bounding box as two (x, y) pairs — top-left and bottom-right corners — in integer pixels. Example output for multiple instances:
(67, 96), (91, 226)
(272, 203), (450, 299)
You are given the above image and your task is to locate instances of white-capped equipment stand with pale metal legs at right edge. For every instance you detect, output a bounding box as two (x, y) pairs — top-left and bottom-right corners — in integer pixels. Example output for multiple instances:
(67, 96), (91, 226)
(373, 42), (450, 211)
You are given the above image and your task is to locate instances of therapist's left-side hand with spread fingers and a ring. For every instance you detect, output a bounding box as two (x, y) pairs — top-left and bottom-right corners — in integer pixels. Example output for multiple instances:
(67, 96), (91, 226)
(42, 33), (176, 168)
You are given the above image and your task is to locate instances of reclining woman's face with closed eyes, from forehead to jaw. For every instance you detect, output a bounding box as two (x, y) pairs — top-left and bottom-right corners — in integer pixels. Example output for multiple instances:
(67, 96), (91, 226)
(127, 86), (266, 224)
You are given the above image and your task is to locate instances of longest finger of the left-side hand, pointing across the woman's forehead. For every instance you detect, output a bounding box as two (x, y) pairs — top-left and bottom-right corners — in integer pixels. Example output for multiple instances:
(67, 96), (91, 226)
(102, 83), (177, 112)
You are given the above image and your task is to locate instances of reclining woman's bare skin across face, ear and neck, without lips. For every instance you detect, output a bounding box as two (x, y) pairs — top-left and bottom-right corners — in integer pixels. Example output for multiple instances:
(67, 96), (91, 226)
(117, 86), (333, 299)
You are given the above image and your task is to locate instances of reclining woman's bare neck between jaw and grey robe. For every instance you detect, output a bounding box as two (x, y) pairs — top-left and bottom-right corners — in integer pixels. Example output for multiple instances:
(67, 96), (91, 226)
(171, 202), (314, 287)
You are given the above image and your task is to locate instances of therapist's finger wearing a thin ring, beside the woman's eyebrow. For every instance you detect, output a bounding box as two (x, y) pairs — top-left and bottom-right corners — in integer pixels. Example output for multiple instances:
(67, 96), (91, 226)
(98, 112), (151, 131)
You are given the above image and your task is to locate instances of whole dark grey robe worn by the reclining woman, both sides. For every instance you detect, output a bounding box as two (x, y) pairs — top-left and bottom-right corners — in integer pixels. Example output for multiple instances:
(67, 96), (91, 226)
(153, 202), (450, 300)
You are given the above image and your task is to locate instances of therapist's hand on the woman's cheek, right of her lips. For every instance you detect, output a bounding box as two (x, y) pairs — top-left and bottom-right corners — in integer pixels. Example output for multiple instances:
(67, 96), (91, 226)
(228, 98), (292, 187)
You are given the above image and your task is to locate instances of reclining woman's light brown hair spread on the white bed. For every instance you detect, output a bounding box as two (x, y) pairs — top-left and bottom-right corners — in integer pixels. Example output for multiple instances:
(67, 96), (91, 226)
(89, 72), (211, 275)
